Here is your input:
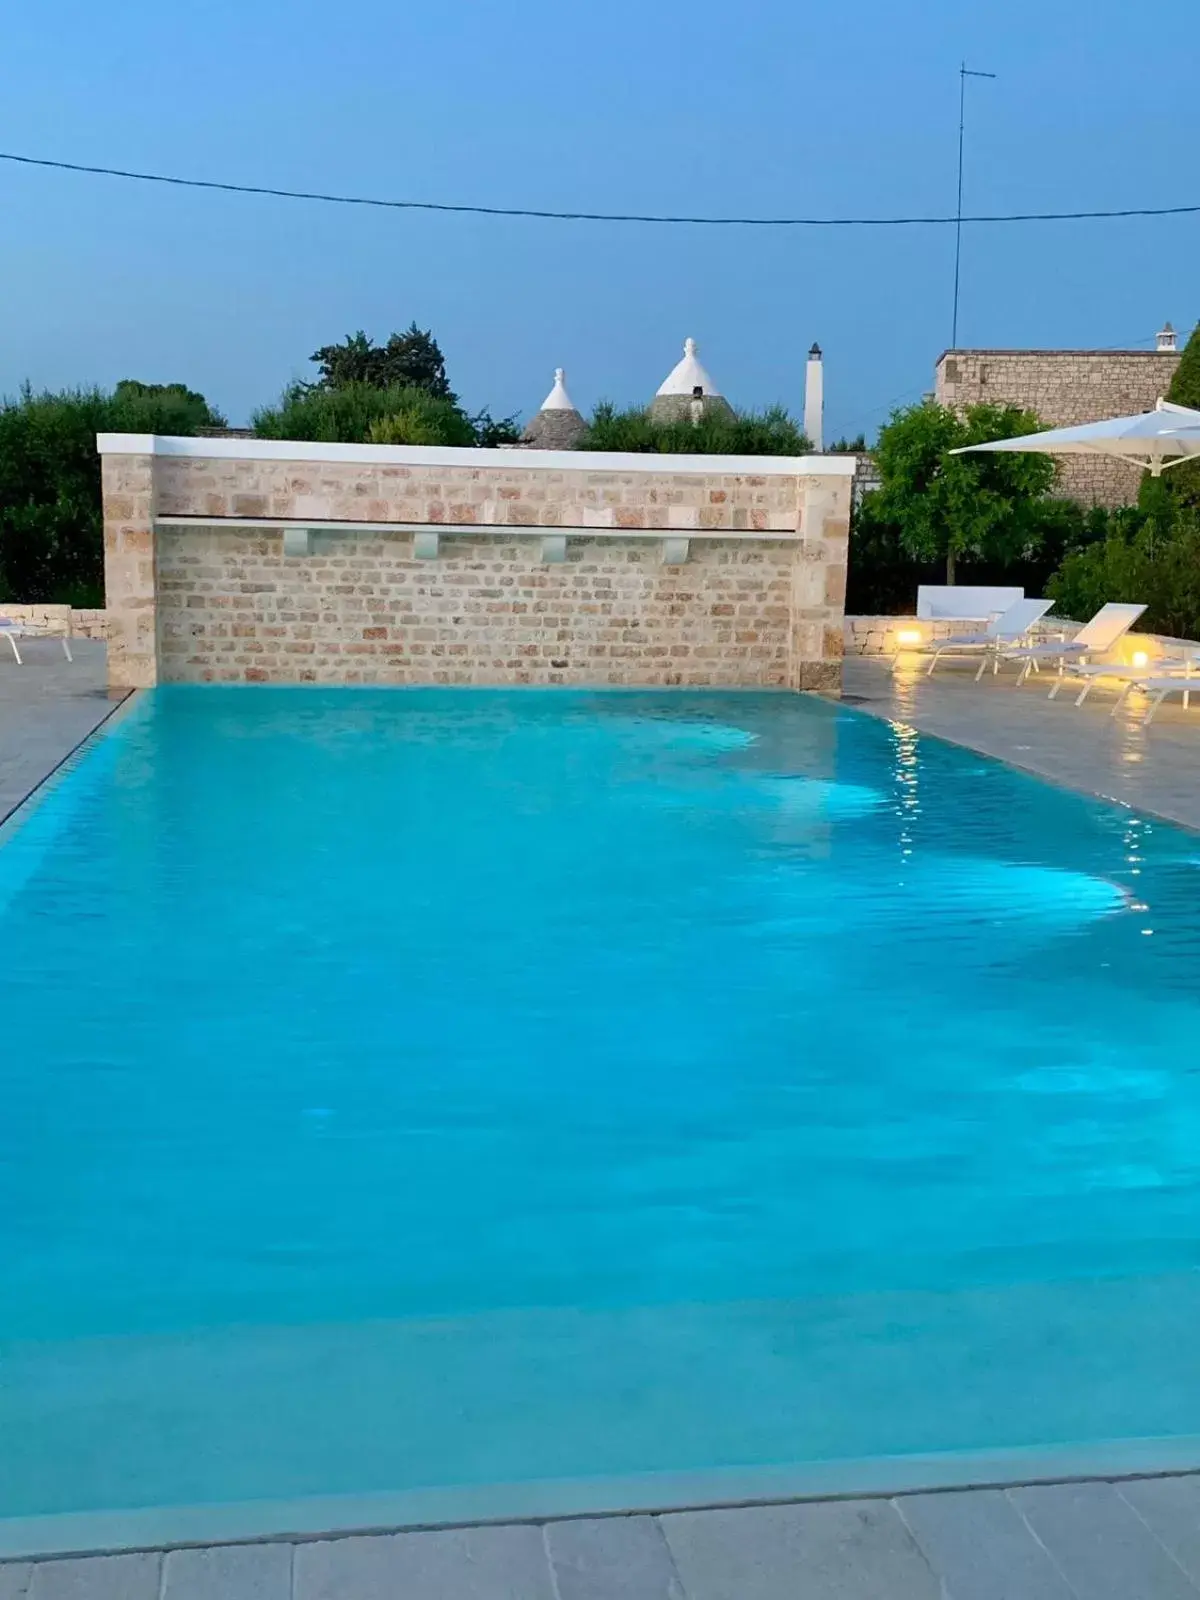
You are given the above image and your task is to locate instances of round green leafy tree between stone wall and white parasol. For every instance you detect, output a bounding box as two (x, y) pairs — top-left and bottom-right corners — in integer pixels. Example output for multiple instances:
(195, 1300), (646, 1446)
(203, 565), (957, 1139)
(874, 400), (1056, 584)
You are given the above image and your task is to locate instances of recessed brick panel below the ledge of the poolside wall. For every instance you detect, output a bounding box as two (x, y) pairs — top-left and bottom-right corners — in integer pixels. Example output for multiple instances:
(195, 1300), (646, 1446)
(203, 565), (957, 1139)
(158, 526), (792, 688)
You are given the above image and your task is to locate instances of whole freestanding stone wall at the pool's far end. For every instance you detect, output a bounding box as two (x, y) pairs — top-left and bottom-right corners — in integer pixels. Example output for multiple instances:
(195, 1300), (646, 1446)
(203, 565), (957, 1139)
(101, 435), (854, 691)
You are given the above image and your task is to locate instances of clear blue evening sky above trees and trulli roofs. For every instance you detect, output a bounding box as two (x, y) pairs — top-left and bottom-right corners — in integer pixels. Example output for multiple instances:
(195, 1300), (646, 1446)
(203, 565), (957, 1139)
(0, 0), (1200, 434)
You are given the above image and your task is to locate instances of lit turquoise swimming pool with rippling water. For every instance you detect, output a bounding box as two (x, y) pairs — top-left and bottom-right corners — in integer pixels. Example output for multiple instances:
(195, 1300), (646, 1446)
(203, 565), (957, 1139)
(0, 688), (1200, 1550)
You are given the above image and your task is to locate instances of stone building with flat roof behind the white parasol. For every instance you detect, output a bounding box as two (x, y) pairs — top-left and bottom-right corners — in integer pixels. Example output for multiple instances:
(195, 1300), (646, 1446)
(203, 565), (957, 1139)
(934, 322), (1179, 506)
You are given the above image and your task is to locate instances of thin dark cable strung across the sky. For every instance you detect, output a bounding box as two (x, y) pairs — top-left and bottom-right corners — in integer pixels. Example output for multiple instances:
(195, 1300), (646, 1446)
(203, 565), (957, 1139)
(0, 150), (1200, 227)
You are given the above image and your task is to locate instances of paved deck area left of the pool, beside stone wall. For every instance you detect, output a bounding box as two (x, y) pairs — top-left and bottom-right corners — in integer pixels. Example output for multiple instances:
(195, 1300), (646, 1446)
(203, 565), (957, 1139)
(0, 638), (117, 821)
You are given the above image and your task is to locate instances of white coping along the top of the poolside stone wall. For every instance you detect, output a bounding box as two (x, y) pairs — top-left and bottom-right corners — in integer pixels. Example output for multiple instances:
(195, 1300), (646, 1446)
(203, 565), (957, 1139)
(96, 434), (858, 478)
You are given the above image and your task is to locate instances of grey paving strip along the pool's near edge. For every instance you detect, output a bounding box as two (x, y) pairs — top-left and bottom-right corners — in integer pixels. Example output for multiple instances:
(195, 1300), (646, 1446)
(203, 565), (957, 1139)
(16, 1475), (1200, 1600)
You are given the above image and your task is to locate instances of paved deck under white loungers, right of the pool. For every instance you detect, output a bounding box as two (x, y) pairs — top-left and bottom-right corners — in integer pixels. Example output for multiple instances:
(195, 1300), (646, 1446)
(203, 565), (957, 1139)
(845, 656), (1200, 829)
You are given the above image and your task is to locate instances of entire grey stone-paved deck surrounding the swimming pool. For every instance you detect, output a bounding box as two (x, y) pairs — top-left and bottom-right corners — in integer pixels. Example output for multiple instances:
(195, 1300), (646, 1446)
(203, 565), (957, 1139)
(0, 640), (1200, 1600)
